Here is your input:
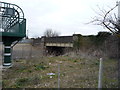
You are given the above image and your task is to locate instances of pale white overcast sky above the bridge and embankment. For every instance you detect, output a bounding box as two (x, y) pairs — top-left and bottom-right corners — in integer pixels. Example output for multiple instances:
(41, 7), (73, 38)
(1, 0), (117, 37)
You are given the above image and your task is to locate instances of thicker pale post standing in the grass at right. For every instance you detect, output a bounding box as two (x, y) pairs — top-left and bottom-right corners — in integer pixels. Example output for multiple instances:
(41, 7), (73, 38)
(98, 58), (103, 89)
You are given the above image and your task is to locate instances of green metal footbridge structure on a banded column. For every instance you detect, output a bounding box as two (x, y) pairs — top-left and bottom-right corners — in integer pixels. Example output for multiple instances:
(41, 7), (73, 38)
(0, 2), (26, 66)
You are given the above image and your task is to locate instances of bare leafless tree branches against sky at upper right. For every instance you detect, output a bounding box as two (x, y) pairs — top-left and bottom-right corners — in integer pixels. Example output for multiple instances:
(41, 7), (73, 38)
(90, 4), (120, 34)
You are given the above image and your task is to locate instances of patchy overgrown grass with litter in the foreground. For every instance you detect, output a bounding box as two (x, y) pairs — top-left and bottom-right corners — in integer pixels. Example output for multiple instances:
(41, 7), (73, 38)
(3, 56), (118, 88)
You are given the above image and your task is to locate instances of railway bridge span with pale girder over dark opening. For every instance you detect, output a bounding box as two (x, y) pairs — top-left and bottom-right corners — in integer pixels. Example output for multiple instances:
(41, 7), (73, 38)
(42, 36), (73, 56)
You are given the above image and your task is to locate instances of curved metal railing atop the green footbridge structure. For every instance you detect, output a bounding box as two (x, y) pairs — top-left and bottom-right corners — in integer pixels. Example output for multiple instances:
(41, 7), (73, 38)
(0, 1), (24, 32)
